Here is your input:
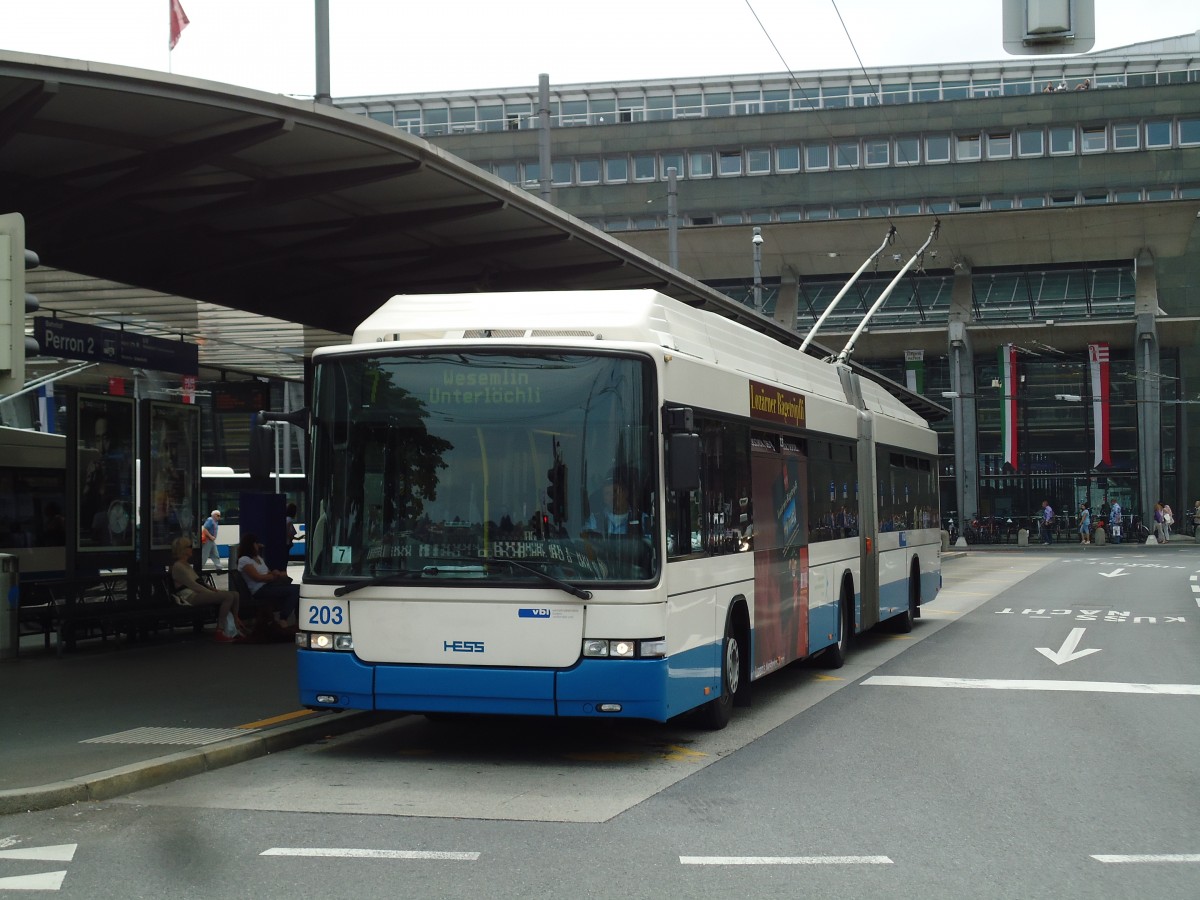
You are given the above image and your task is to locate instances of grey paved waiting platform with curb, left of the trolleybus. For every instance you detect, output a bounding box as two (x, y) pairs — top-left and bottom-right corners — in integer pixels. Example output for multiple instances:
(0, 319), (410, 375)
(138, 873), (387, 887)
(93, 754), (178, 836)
(0, 629), (379, 814)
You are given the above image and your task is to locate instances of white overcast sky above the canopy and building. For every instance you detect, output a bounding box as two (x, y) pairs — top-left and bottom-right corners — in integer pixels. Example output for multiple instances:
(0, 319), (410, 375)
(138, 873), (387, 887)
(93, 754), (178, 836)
(0, 0), (1200, 97)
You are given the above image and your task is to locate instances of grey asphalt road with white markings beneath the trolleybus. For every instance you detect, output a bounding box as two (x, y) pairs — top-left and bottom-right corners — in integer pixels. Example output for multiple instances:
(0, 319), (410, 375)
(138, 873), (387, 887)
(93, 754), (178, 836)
(0, 545), (1200, 900)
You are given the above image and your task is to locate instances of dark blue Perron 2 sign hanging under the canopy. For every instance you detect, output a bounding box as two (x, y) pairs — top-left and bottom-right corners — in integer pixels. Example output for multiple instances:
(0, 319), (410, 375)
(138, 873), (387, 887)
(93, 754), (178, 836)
(34, 316), (200, 376)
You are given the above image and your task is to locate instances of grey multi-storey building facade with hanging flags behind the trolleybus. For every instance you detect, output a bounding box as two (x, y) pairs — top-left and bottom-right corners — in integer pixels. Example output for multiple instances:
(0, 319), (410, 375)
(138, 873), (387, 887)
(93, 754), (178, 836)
(337, 32), (1200, 527)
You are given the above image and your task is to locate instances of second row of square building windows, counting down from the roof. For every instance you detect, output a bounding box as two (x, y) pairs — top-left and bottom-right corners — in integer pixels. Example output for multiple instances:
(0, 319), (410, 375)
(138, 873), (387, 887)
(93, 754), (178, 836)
(488, 118), (1200, 187)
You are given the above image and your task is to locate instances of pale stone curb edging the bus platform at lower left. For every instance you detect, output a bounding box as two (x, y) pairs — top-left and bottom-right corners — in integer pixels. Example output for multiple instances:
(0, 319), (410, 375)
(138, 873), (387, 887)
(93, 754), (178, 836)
(0, 710), (389, 816)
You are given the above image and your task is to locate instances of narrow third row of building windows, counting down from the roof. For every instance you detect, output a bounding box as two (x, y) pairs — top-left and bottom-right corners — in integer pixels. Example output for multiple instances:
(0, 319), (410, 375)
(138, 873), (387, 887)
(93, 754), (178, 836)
(584, 185), (1200, 232)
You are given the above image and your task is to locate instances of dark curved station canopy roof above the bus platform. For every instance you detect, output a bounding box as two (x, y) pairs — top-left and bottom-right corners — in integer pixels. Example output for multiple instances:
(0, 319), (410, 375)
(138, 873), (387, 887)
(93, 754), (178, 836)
(0, 53), (946, 418)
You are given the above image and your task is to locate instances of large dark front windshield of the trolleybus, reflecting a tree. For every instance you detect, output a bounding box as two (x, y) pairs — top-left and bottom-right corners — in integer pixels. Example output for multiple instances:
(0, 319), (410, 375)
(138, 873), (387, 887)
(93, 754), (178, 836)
(307, 349), (661, 587)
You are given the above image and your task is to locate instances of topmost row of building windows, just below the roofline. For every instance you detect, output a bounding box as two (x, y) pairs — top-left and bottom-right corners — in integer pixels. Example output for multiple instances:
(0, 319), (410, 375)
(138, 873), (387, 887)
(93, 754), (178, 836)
(342, 61), (1200, 136)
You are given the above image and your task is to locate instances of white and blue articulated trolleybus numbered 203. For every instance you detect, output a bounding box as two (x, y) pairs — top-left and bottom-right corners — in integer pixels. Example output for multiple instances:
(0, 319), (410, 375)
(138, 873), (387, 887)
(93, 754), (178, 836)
(296, 290), (941, 727)
